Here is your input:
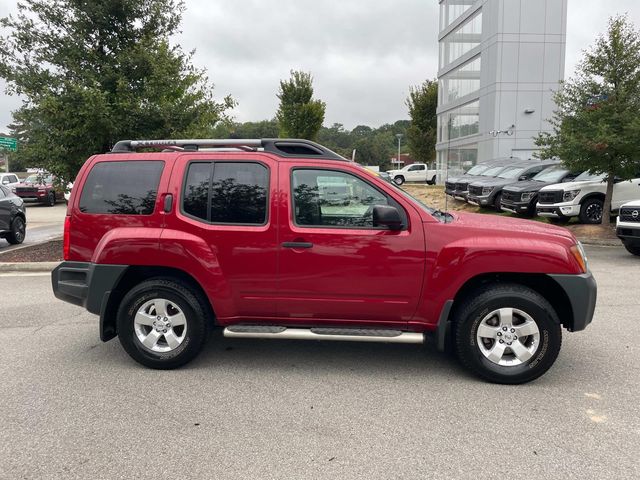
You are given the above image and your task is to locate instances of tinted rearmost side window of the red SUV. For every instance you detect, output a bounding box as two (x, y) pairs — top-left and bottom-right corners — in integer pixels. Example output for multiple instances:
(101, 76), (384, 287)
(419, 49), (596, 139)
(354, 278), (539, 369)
(80, 161), (164, 215)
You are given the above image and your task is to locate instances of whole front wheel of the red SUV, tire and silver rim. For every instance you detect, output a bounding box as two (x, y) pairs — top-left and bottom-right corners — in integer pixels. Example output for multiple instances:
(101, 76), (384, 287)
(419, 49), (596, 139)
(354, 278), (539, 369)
(454, 284), (562, 384)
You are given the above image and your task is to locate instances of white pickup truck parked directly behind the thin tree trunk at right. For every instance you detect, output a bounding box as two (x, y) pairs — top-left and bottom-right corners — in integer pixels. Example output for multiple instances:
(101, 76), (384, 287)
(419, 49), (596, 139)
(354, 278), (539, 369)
(536, 172), (640, 223)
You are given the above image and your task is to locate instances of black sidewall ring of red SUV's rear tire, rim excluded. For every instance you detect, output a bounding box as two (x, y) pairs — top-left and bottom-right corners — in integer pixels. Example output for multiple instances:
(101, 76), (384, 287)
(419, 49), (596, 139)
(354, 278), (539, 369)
(118, 287), (206, 368)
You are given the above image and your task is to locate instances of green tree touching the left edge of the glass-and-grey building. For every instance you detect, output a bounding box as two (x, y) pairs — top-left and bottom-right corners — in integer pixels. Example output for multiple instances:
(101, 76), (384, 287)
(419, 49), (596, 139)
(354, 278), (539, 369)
(406, 80), (438, 167)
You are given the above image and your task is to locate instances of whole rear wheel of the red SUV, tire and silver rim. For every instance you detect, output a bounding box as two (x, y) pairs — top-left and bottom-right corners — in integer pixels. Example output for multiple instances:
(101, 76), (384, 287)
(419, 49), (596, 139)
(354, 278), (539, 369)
(117, 278), (210, 370)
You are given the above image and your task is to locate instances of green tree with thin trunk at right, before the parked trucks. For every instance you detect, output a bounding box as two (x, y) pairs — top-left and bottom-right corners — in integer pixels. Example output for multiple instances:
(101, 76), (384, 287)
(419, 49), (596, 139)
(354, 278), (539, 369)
(536, 16), (640, 224)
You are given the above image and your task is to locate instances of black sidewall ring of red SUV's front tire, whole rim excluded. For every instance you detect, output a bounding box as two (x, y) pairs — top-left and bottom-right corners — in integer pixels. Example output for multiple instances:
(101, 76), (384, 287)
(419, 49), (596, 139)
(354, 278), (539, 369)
(458, 294), (562, 383)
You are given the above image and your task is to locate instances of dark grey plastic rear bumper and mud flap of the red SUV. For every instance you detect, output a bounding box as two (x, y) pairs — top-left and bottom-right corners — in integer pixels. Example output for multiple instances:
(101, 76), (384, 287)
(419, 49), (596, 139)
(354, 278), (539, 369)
(51, 262), (127, 341)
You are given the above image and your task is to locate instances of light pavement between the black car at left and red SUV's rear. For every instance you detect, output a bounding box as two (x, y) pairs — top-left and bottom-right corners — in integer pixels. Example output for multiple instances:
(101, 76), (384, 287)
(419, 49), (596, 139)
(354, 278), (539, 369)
(0, 203), (67, 253)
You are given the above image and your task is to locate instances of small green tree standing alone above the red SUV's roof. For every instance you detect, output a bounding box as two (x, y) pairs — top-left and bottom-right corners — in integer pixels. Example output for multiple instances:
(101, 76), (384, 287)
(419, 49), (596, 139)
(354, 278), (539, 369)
(276, 70), (326, 140)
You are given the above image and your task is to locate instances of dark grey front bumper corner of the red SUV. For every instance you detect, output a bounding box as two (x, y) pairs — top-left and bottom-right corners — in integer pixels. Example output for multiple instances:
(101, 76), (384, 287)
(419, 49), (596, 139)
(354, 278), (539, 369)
(549, 272), (598, 332)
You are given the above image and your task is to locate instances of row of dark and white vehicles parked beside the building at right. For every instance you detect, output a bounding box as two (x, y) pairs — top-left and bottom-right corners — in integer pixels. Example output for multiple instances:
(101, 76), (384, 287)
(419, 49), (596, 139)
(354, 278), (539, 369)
(445, 158), (640, 255)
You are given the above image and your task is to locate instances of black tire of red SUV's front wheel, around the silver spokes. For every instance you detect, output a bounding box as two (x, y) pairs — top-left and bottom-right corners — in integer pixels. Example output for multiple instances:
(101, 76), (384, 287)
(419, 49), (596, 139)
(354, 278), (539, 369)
(454, 283), (562, 384)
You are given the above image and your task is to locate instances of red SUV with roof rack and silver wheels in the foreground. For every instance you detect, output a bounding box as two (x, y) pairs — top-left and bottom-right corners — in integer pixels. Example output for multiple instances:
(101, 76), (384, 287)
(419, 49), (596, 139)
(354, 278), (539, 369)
(52, 139), (596, 383)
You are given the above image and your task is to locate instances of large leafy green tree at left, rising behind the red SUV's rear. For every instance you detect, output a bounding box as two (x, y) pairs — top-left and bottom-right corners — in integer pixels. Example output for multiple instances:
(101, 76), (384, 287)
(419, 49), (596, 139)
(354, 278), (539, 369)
(0, 0), (233, 179)
